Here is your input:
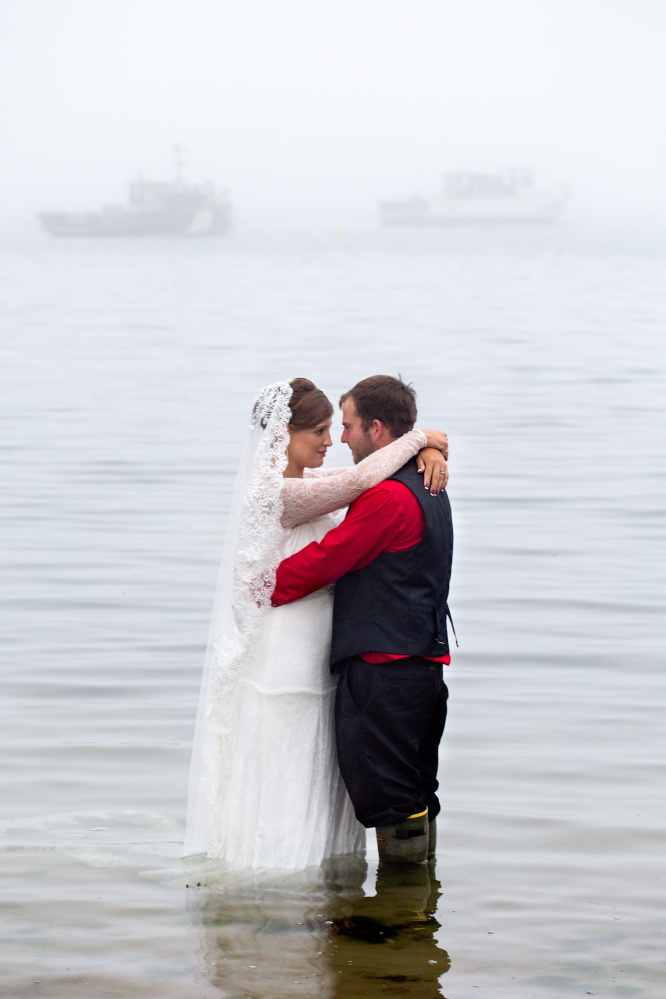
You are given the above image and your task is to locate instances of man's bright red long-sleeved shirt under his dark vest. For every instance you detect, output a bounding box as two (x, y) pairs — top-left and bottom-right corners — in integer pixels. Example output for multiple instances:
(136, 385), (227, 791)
(271, 479), (451, 664)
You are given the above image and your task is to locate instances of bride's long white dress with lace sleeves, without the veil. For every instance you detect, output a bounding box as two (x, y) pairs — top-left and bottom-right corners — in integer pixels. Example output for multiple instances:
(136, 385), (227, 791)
(188, 430), (426, 870)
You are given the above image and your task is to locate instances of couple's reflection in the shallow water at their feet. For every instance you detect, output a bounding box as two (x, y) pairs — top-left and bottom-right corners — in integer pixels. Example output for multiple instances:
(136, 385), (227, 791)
(188, 857), (451, 999)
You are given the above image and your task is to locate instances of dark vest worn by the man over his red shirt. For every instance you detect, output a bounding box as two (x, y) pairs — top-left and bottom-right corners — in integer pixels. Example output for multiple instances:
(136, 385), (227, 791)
(331, 459), (453, 666)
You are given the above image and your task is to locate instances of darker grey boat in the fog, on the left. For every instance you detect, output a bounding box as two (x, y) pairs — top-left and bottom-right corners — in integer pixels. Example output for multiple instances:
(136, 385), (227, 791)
(39, 177), (231, 236)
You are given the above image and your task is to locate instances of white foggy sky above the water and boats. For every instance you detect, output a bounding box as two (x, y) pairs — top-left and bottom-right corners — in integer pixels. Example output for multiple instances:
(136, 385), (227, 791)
(0, 0), (666, 223)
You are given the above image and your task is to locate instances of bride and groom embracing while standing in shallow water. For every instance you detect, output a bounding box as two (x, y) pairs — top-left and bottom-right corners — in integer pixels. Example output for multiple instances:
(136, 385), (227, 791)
(185, 375), (453, 870)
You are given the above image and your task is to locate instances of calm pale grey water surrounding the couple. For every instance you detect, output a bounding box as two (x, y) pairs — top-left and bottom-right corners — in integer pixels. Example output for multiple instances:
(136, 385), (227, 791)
(0, 223), (666, 999)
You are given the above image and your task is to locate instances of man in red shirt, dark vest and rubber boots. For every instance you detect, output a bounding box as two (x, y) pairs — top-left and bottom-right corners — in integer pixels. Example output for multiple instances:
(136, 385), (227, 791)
(272, 375), (453, 862)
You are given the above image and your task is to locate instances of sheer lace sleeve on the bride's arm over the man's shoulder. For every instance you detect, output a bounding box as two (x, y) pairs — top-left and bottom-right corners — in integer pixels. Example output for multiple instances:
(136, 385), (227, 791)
(282, 430), (427, 527)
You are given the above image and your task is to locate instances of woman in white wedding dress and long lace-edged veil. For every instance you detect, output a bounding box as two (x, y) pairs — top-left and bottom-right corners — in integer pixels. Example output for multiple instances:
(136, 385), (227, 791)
(185, 378), (446, 870)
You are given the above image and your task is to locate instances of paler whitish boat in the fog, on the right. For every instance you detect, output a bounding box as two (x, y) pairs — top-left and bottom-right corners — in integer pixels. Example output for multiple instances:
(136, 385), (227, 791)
(379, 170), (570, 226)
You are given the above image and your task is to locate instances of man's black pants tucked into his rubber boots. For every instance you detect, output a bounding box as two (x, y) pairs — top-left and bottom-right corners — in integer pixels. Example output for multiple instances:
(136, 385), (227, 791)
(335, 656), (448, 828)
